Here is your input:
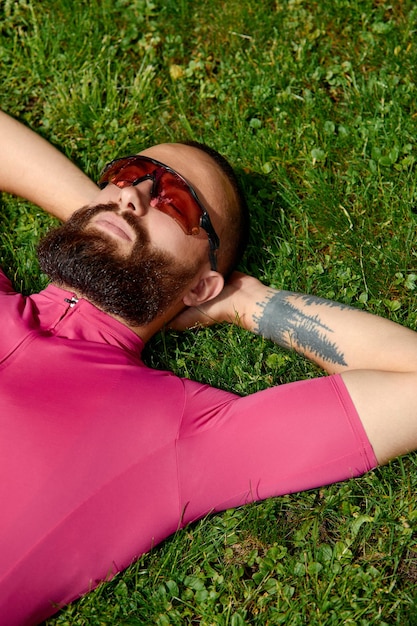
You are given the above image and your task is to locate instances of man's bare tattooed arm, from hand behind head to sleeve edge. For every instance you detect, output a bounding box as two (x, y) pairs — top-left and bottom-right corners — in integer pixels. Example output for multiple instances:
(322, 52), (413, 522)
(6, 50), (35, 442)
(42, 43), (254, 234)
(173, 273), (417, 463)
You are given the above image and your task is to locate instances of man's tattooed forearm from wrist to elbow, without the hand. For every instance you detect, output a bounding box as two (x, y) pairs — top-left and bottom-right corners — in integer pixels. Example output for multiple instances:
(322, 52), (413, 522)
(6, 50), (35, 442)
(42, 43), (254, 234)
(244, 287), (417, 373)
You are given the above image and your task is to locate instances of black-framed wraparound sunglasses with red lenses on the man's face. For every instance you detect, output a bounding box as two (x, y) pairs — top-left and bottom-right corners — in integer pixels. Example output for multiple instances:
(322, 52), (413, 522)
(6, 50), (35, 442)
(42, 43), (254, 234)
(98, 155), (220, 271)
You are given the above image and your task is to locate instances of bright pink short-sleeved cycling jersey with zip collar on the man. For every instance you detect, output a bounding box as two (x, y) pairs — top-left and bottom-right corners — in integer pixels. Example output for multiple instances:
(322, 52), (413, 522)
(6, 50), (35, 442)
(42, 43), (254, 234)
(0, 273), (376, 626)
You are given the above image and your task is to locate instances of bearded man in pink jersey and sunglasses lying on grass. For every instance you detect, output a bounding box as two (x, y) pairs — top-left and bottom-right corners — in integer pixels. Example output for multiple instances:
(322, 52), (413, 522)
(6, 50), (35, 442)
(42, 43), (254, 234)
(0, 109), (417, 626)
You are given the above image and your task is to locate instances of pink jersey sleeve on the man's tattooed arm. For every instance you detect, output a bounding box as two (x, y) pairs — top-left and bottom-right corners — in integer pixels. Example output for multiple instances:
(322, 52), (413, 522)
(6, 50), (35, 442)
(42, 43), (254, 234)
(177, 375), (377, 523)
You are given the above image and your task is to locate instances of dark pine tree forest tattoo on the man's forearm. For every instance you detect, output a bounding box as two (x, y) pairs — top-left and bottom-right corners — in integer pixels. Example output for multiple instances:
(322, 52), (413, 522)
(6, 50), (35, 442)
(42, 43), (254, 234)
(253, 291), (352, 366)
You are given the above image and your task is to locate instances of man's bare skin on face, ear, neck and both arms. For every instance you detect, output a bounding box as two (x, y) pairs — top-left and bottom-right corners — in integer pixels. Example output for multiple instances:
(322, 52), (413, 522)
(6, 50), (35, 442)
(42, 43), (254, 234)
(0, 109), (417, 463)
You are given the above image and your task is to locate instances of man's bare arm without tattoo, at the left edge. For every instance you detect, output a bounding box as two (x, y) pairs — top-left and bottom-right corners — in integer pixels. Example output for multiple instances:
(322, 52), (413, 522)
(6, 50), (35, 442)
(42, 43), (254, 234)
(0, 111), (97, 220)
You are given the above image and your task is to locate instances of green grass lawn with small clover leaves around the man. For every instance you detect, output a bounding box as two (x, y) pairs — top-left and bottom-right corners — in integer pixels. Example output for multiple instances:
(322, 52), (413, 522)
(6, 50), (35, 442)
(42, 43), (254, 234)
(0, 0), (417, 626)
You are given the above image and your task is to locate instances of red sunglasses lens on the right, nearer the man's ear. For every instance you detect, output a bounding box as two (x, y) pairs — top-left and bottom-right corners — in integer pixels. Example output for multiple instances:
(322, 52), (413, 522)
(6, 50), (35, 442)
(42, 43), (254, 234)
(151, 167), (202, 235)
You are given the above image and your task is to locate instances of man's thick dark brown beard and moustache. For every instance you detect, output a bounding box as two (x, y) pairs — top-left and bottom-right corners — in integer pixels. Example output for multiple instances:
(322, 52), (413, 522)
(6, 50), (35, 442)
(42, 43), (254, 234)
(38, 204), (200, 326)
